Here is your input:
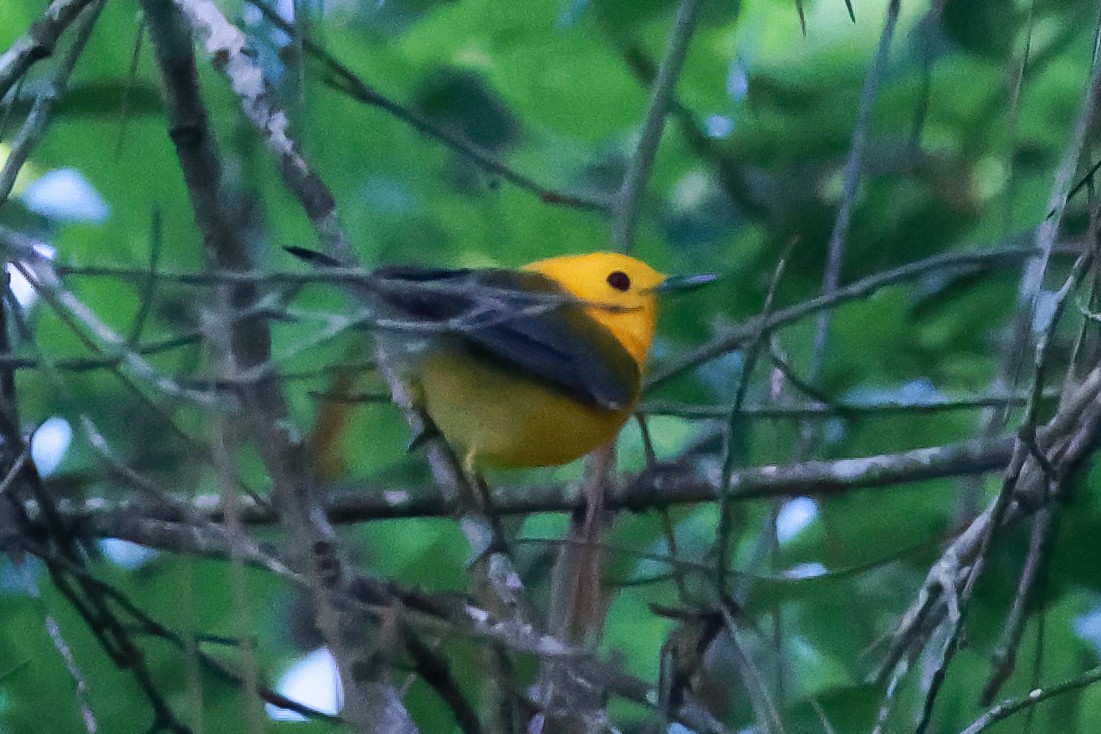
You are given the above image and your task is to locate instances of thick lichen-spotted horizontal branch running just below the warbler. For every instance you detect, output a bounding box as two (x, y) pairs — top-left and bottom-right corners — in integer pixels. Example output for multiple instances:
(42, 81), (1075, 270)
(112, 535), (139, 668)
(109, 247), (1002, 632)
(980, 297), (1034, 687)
(51, 438), (1013, 555)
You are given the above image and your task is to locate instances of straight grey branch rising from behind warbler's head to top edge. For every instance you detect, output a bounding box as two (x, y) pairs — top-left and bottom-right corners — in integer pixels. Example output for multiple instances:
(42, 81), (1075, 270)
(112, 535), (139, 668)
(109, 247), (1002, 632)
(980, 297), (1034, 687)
(612, 0), (702, 252)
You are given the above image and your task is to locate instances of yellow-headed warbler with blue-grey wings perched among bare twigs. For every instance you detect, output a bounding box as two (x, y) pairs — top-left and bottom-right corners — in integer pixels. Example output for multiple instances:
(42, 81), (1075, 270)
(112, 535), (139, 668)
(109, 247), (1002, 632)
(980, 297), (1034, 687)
(288, 248), (713, 471)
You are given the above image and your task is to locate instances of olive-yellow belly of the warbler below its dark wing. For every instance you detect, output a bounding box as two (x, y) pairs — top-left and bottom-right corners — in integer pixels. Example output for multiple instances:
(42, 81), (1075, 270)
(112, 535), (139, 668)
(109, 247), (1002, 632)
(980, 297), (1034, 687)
(415, 351), (634, 467)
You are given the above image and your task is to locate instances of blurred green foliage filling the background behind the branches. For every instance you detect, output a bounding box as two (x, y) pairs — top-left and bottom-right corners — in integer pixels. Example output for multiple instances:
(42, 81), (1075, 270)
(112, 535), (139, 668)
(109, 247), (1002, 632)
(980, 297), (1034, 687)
(0, 0), (1101, 734)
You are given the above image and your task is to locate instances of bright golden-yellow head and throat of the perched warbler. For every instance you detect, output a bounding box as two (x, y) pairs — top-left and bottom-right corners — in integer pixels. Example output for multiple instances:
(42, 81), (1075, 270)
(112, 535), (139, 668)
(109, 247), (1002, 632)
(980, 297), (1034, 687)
(522, 252), (665, 368)
